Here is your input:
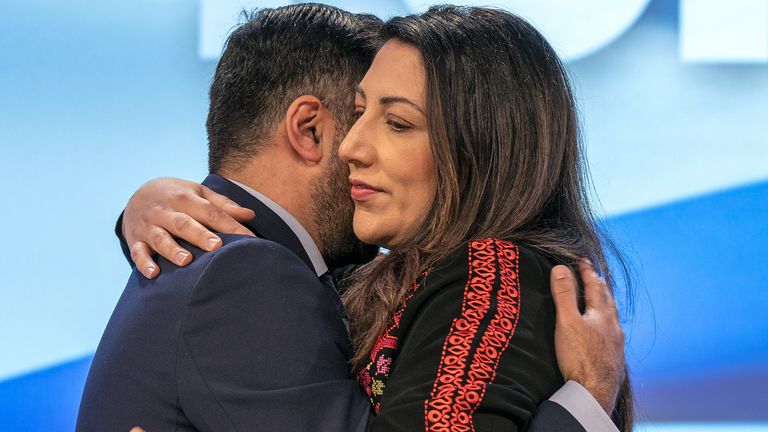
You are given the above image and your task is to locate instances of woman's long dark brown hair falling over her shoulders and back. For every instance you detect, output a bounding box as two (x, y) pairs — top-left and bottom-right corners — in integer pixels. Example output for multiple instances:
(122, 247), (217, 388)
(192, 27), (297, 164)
(344, 6), (633, 431)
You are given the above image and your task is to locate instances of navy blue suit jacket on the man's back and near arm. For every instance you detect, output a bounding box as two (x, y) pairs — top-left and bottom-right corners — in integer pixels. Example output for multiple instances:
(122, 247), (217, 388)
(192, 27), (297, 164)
(77, 175), (369, 432)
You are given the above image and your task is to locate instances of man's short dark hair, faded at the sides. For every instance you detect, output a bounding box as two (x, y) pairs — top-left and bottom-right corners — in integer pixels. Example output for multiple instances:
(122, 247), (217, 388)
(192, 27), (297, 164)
(206, 3), (381, 172)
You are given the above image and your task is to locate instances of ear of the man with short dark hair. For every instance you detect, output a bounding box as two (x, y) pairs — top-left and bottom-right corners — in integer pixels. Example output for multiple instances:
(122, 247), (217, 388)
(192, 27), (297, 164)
(285, 95), (335, 164)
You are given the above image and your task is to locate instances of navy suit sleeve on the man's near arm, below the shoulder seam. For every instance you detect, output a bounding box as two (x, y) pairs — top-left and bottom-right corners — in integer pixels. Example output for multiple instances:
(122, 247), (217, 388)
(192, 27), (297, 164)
(177, 238), (370, 431)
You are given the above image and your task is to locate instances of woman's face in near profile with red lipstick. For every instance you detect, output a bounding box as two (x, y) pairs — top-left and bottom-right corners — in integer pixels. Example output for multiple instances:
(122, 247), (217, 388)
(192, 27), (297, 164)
(339, 40), (437, 249)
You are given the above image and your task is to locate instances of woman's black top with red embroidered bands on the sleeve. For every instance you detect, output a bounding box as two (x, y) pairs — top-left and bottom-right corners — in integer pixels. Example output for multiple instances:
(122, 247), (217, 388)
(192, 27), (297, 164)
(358, 239), (563, 431)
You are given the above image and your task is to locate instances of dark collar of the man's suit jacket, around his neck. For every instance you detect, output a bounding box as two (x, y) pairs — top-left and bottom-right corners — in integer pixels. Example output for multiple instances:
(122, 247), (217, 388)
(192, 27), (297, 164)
(203, 174), (315, 273)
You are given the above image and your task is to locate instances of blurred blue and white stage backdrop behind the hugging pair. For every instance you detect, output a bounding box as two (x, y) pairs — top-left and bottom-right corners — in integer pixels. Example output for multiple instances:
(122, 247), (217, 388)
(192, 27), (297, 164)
(0, 0), (768, 432)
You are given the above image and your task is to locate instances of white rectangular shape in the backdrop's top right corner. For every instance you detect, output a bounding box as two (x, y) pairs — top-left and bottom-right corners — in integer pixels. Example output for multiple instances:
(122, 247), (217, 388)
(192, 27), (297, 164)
(680, 0), (768, 63)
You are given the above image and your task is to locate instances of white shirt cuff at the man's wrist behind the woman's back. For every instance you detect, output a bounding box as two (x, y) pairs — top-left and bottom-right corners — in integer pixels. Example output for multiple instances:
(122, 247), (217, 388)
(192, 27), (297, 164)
(549, 381), (619, 432)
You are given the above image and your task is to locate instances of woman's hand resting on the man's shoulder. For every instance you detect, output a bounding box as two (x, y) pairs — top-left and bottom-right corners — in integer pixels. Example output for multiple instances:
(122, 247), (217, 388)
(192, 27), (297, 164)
(122, 178), (255, 279)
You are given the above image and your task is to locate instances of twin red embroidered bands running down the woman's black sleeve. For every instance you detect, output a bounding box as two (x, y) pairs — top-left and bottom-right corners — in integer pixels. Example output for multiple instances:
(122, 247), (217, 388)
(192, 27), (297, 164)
(424, 239), (520, 431)
